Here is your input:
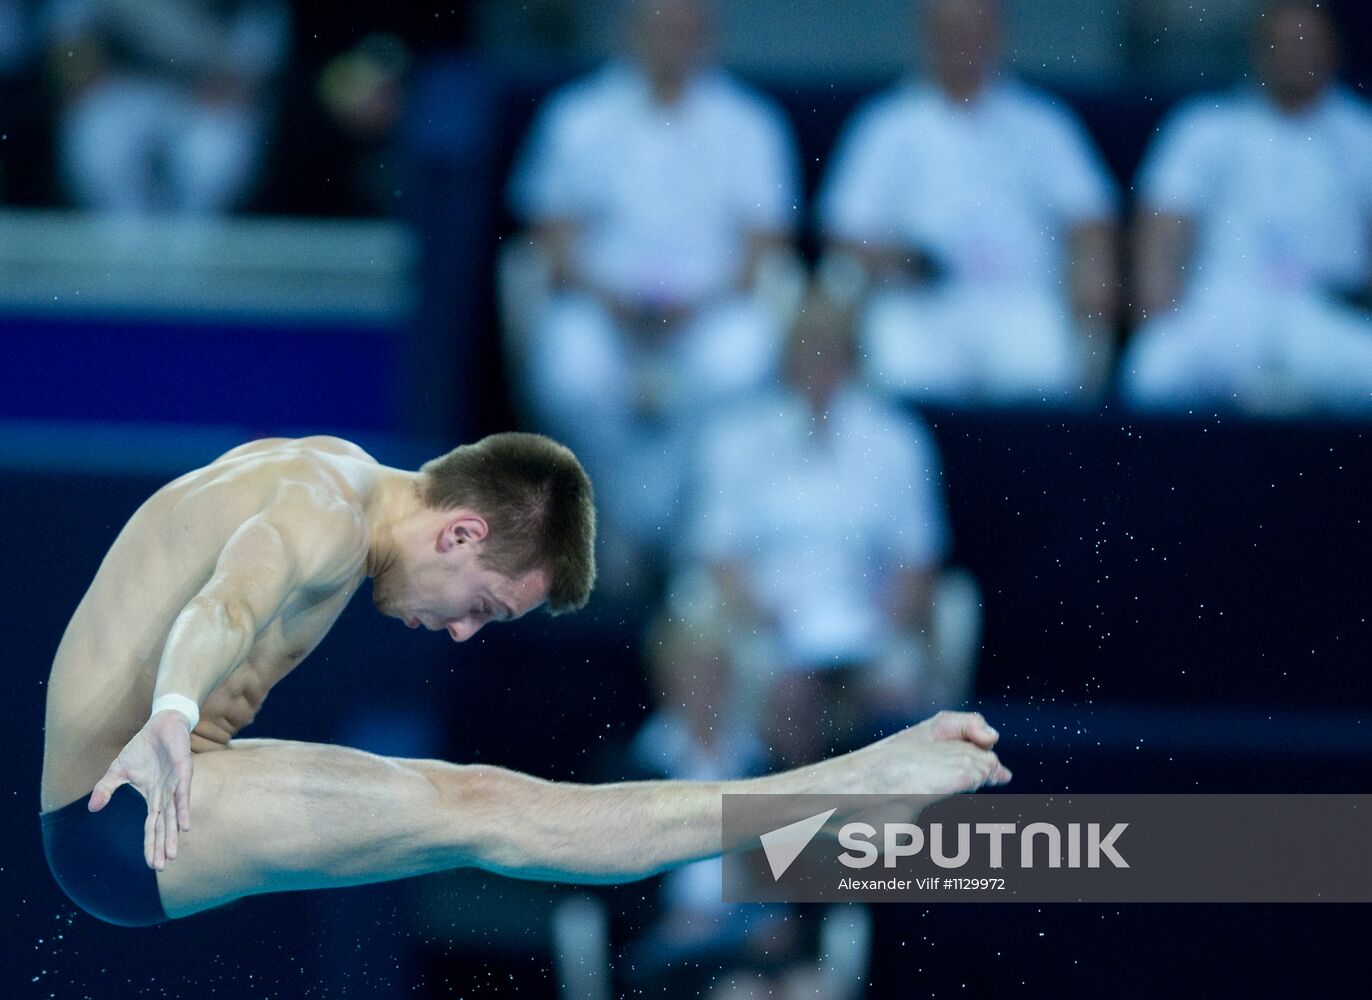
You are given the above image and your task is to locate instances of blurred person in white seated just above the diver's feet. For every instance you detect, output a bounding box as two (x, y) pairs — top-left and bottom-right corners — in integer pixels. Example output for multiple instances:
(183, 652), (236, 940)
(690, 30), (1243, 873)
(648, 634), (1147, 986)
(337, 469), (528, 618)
(676, 288), (980, 765)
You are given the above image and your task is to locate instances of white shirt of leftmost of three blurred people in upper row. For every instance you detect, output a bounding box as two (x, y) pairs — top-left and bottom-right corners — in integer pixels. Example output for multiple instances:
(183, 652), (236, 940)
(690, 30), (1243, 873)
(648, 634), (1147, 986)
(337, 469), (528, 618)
(510, 63), (799, 302)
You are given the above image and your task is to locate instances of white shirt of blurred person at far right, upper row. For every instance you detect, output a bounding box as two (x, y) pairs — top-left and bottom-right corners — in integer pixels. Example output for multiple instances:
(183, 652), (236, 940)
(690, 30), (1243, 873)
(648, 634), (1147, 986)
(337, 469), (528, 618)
(1139, 88), (1372, 296)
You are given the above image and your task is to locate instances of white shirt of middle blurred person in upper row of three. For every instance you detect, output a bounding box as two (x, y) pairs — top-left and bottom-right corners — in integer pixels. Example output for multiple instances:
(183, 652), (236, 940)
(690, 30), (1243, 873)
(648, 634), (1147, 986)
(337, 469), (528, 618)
(819, 81), (1117, 288)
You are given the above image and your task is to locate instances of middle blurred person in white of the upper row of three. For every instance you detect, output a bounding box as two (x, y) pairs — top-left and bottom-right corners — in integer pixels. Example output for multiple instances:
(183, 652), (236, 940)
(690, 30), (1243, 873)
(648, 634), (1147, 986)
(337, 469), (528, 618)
(819, 0), (1118, 405)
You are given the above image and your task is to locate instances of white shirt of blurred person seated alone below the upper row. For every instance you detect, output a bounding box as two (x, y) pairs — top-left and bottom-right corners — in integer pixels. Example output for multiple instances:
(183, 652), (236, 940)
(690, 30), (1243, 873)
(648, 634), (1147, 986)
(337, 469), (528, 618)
(689, 387), (949, 663)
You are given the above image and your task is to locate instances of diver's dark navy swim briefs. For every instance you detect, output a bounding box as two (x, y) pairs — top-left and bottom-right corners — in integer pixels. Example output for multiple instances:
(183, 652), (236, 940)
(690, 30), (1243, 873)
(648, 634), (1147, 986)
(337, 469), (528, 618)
(38, 785), (167, 927)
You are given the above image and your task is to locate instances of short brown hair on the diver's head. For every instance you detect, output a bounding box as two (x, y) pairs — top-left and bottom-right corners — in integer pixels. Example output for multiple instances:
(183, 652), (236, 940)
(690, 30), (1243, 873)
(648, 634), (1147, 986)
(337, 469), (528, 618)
(420, 432), (595, 615)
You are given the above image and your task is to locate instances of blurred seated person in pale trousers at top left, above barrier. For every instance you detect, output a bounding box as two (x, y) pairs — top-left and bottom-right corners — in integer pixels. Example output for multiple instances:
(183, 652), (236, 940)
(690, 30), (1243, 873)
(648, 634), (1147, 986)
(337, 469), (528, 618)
(51, 0), (289, 214)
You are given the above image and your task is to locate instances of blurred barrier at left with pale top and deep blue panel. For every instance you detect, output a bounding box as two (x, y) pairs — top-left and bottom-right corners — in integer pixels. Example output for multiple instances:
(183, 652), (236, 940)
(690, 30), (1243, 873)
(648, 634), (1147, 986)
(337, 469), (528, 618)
(0, 210), (414, 427)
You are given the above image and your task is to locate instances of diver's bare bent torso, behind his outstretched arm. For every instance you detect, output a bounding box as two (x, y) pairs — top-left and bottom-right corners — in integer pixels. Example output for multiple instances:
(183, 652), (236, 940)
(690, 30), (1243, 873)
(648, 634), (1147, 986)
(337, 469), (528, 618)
(40, 438), (381, 812)
